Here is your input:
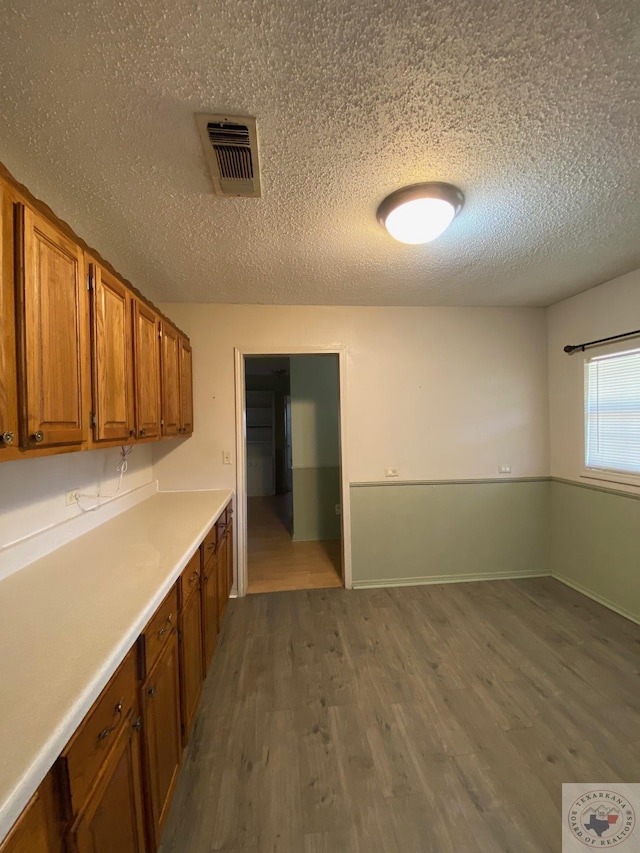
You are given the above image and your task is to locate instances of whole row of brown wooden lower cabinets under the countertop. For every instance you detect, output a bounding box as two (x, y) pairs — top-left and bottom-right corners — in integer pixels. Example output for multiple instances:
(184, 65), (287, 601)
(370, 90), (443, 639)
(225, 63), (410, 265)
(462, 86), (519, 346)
(0, 506), (233, 853)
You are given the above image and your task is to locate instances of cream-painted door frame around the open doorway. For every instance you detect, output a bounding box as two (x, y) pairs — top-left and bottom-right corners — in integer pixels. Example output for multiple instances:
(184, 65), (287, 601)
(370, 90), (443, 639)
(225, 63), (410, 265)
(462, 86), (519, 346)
(234, 346), (352, 597)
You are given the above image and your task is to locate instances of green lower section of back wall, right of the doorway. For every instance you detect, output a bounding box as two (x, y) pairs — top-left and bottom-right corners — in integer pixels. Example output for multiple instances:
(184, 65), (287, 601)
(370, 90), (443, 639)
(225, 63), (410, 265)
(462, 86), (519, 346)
(351, 479), (551, 587)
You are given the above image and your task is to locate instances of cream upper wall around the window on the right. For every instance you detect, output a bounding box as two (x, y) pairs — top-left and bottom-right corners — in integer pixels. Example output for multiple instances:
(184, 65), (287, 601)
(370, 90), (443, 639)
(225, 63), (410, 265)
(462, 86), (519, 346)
(548, 270), (640, 492)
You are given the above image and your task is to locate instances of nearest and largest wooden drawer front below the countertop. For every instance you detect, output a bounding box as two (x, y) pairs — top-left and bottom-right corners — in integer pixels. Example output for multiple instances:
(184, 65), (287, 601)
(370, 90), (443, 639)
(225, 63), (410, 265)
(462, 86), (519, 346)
(61, 650), (138, 814)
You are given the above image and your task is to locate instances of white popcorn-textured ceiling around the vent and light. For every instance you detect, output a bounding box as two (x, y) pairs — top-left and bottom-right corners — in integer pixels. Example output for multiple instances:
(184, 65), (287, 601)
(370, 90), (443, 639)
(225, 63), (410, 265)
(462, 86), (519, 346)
(0, 0), (640, 305)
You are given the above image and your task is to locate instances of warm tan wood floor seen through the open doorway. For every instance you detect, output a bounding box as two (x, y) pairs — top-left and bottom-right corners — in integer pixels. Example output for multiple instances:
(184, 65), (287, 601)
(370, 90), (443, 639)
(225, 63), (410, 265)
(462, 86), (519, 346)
(247, 494), (342, 593)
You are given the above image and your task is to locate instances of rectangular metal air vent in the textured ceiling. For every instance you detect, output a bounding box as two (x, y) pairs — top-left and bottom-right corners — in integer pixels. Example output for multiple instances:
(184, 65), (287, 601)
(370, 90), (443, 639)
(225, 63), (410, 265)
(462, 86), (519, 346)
(196, 114), (261, 198)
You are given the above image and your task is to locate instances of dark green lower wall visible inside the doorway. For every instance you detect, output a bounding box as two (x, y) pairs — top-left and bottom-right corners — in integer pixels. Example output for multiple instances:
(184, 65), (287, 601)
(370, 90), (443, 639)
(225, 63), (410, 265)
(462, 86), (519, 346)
(292, 468), (341, 541)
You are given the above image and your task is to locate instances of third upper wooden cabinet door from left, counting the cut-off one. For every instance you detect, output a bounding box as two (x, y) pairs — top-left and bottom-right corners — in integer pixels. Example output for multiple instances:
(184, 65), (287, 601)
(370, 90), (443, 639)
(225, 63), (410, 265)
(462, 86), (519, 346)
(90, 264), (133, 441)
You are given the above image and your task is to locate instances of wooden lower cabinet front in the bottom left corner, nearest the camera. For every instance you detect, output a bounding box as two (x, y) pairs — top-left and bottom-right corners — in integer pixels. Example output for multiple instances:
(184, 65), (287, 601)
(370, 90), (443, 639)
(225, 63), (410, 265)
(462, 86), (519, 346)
(0, 773), (63, 853)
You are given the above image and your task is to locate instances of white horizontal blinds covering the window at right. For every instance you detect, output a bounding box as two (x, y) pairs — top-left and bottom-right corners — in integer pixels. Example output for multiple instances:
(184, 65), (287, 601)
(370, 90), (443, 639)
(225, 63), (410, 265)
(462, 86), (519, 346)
(585, 349), (640, 474)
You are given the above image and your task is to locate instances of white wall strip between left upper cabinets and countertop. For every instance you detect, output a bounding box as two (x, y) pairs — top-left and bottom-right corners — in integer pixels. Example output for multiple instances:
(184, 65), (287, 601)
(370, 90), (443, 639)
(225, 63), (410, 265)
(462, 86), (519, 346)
(0, 444), (153, 564)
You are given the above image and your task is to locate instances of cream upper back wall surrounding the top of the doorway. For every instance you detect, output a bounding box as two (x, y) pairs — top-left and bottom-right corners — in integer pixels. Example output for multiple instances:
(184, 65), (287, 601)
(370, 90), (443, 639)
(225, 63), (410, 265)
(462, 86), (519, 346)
(154, 304), (549, 489)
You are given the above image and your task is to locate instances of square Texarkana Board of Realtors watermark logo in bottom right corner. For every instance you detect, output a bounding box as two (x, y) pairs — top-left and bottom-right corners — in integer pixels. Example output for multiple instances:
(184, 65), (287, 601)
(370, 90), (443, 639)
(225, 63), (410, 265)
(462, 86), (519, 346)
(562, 783), (640, 853)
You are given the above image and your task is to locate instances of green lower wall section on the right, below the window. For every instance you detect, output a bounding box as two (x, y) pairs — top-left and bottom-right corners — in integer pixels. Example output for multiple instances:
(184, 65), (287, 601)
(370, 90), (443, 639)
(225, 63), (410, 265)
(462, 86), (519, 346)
(551, 480), (640, 622)
